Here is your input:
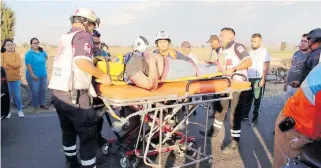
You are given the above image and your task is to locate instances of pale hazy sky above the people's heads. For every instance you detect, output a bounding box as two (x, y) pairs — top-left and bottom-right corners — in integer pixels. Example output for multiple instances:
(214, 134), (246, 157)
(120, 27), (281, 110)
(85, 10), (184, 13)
(5, 0), (321, 46)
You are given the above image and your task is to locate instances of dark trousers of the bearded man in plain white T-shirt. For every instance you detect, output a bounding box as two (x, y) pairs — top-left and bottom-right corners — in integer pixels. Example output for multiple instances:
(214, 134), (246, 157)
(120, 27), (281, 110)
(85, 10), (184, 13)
(243, 78), (265, 118)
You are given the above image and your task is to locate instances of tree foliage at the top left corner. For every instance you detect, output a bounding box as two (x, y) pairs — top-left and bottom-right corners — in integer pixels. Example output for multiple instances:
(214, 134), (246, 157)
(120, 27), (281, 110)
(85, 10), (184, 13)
(1, 1), (16, 41)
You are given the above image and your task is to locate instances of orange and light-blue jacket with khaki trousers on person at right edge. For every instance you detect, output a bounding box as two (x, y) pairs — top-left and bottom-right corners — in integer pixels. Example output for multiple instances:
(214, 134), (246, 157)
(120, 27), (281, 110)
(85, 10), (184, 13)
(273, 63), (321, 168)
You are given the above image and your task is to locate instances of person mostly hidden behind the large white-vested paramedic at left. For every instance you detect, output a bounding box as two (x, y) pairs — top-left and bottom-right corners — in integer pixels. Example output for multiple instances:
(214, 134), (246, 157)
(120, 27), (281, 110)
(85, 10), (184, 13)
(93, 30), (108, 146)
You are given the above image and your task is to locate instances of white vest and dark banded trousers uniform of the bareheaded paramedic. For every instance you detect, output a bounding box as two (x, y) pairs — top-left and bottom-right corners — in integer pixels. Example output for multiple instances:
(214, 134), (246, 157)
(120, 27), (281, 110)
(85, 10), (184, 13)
(200, 41), (251, 152)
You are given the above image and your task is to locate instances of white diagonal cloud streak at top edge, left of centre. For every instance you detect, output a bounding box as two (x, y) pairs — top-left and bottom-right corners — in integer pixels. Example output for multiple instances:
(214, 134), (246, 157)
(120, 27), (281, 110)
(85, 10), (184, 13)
(106, 0), (160, 25)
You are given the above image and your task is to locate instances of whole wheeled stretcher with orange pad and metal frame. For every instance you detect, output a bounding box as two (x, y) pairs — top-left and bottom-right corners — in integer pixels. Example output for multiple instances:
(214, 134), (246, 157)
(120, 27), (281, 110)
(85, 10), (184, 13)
(98, 74), (251, 168)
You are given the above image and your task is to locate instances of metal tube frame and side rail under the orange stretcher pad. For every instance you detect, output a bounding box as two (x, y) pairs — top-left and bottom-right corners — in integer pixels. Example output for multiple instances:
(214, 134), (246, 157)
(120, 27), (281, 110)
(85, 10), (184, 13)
(100, 74), (250, 168)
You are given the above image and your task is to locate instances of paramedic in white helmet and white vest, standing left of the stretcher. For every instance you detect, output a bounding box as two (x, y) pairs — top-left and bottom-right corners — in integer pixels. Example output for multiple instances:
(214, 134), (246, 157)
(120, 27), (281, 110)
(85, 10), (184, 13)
(49, 8), (111, 168)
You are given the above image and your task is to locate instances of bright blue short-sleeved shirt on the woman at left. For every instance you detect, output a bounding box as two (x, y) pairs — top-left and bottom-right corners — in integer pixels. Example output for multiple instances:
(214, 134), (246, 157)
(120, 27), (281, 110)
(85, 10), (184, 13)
(25, 49), (48, 78)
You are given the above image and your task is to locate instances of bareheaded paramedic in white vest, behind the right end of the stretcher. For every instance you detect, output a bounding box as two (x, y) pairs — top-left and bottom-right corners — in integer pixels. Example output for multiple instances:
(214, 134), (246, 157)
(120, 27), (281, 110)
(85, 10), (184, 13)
(200, 28), (252, 153)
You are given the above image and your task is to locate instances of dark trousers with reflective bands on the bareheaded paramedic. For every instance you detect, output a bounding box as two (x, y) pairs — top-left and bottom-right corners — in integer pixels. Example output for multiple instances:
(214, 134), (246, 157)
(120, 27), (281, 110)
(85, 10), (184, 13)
(213, 92), (245, 141)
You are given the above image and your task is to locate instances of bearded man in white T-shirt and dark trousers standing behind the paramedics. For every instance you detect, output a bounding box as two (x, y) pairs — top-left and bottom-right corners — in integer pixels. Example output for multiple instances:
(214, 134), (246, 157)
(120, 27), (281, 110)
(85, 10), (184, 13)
(243, 33), (271, 125)
